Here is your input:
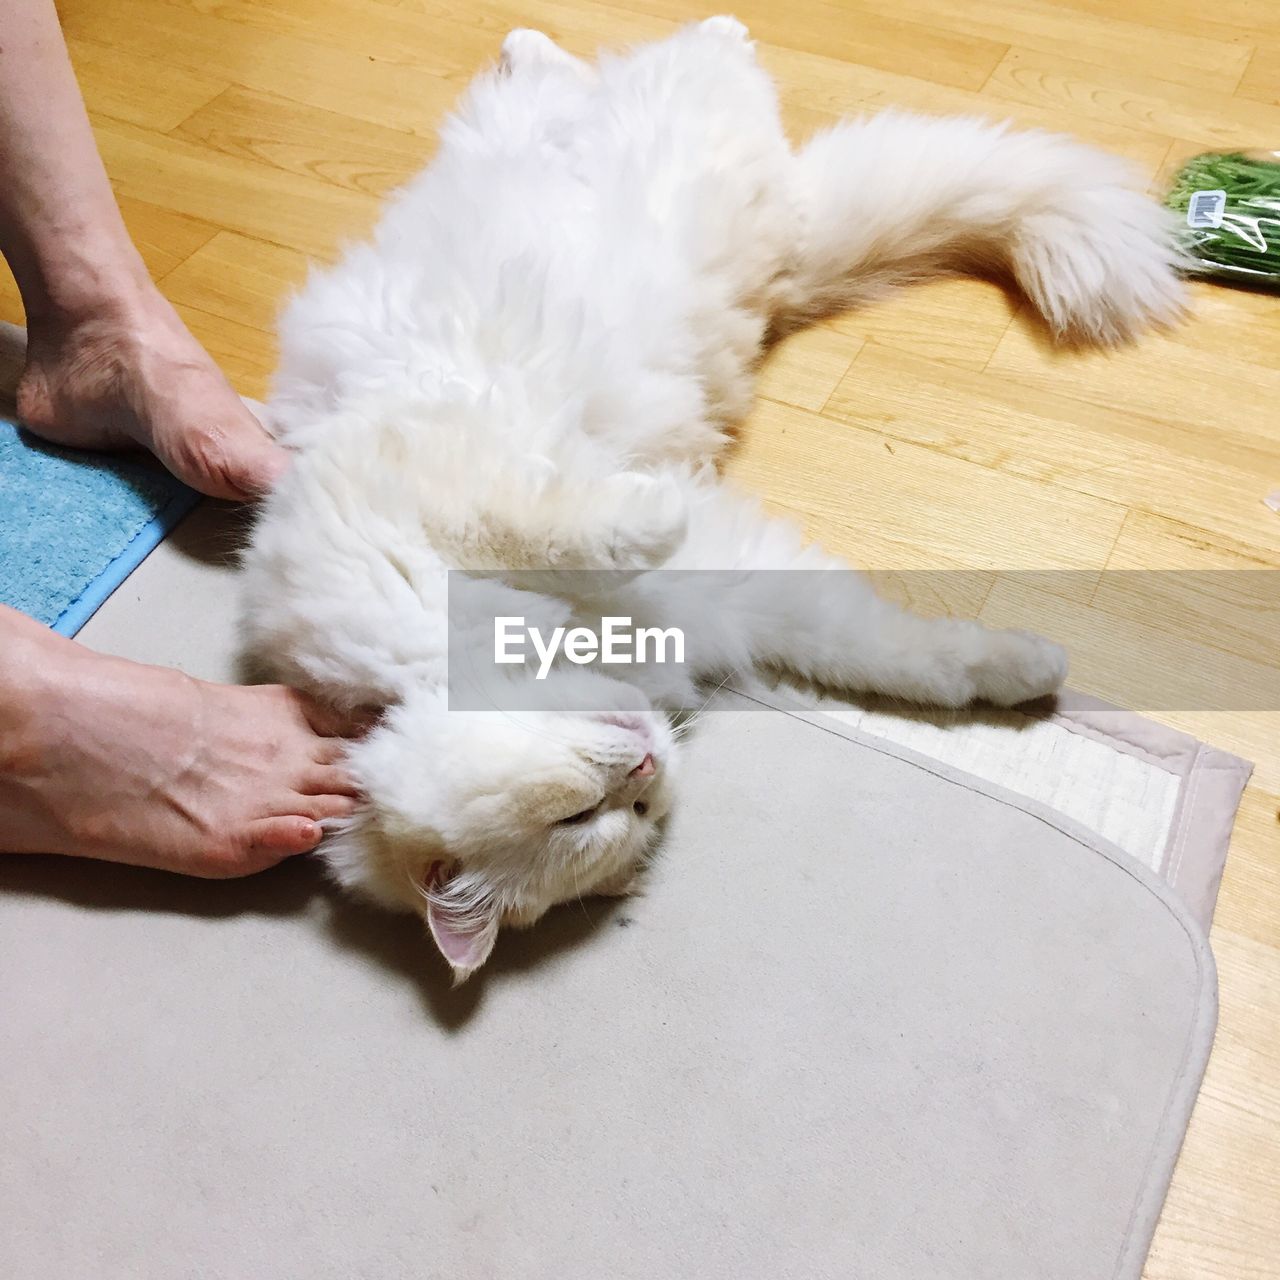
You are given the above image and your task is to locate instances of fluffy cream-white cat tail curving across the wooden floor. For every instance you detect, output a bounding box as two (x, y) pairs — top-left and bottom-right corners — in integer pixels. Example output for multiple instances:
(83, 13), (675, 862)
(778, 111), (1183, 343)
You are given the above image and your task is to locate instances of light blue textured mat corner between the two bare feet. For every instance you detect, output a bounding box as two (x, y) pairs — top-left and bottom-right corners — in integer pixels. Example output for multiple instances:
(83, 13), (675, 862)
(0, 419), (200, 636)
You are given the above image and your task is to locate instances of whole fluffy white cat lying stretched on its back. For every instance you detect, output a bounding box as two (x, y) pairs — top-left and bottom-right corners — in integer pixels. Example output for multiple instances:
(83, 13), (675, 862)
(246, 18), (1181, 978)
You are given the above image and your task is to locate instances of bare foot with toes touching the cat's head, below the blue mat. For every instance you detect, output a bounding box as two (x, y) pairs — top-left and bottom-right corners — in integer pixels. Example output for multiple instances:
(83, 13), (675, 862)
(0, 608), (355, 878)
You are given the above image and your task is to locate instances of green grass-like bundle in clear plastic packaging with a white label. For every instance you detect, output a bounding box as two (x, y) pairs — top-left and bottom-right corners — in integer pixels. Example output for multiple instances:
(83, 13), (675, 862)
(1165, 151), (1280, 289)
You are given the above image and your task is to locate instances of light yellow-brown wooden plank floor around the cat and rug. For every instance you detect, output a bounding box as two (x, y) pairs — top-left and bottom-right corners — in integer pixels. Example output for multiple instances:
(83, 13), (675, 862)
(0, 0), (1280, 1280)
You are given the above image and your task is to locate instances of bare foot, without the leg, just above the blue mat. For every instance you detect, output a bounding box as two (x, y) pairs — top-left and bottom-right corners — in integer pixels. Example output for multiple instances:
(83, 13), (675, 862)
(18, 282), (287, 499)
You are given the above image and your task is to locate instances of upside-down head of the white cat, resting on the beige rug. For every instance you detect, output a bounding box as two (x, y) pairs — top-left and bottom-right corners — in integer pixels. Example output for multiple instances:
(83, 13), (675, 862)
(325, 671), (676, 980)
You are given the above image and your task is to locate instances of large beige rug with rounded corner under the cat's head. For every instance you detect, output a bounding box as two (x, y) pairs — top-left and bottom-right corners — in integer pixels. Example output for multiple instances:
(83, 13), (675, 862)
(0, 501), (1248, 1280)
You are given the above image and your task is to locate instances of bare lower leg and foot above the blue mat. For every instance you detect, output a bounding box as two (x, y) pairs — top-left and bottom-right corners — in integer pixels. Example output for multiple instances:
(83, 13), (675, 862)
(0, 0), (287, 498)
